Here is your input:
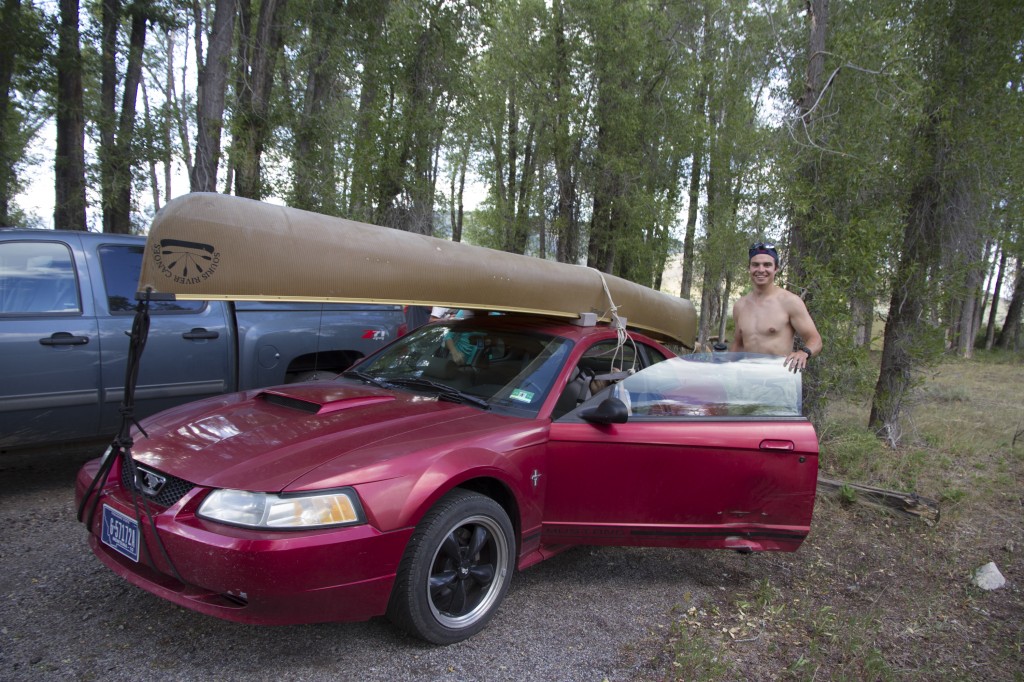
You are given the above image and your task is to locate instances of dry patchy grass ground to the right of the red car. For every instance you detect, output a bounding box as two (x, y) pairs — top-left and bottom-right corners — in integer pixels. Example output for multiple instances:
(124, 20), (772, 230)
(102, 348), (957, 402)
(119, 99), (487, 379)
(638, 353), (1024, 682)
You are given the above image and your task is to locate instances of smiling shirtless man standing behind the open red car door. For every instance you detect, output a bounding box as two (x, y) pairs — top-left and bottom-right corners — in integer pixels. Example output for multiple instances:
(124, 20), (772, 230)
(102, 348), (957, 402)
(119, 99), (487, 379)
(729, 243), (822, 372)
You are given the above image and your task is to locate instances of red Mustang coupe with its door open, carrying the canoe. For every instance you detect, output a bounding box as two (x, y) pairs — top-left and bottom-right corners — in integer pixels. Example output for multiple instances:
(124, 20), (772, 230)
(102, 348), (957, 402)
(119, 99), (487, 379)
(77, 314), (818, 644)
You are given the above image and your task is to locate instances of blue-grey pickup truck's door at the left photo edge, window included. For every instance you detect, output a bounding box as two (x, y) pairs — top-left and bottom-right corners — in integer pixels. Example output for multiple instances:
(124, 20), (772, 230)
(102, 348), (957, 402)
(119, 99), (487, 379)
(0, 236), (99, 449)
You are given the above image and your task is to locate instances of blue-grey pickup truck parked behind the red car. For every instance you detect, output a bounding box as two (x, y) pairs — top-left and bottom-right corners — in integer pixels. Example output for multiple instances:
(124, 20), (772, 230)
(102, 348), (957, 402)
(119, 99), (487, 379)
(0, 228), (407, 453)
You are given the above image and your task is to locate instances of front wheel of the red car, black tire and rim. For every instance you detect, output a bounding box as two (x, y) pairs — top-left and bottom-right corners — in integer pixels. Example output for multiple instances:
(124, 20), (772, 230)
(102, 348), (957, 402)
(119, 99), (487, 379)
(388, 489), (515, 644)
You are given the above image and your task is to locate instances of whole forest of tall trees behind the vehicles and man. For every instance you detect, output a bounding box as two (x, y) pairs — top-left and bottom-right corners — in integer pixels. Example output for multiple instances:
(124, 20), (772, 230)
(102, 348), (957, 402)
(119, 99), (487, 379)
(0, 0), (1024, 445)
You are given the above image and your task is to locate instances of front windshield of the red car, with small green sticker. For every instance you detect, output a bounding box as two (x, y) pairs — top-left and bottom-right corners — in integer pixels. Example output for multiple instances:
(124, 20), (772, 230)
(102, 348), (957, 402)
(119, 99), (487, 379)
(344, 317), (572, 417)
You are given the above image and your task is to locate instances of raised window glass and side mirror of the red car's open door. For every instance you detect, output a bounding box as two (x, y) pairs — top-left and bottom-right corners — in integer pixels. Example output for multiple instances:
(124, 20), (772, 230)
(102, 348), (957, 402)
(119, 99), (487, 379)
(575, 352), (802, 420)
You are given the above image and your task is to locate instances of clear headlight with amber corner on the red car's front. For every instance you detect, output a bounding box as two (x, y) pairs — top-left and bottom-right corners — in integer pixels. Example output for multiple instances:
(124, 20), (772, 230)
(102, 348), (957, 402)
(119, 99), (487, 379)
(197, 488), (365, 529)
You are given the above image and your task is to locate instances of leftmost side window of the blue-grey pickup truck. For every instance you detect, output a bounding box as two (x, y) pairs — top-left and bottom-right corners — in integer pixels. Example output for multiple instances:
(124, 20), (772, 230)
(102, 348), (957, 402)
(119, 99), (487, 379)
(0, 242), (82, 315)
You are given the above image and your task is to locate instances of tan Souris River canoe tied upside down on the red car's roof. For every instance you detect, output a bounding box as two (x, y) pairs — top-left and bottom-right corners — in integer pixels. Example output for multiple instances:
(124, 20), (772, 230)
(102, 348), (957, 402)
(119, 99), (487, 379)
(139, 194), (696, 348)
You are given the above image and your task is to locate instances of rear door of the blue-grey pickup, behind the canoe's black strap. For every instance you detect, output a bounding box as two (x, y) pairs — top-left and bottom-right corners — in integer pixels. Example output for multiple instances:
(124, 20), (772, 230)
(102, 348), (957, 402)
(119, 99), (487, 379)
(94, 242), (234, 432)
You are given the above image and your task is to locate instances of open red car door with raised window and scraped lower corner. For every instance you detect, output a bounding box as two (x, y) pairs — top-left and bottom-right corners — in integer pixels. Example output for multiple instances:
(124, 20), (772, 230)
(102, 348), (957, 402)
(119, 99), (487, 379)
(543, 353), (818, 551)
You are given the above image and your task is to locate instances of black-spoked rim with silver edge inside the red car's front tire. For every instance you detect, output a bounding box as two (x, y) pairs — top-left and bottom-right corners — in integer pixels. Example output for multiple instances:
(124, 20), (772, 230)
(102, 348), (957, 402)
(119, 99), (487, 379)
(427, 509), (509, 629)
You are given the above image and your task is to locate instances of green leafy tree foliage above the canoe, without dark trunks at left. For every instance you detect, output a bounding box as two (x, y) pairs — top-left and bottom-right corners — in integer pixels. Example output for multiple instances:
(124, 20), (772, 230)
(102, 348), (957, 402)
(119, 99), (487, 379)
(0, 0), (1024, 393)
